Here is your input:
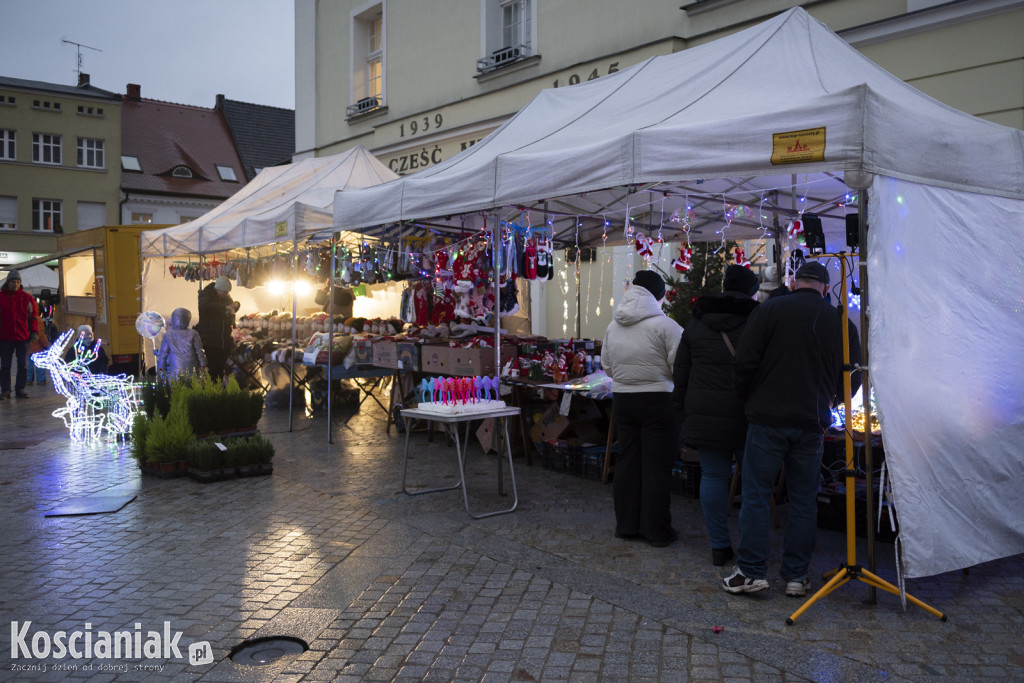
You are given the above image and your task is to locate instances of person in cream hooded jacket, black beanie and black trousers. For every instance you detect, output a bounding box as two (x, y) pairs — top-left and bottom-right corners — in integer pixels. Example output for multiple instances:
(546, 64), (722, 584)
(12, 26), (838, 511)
(601, 270), (683, 548)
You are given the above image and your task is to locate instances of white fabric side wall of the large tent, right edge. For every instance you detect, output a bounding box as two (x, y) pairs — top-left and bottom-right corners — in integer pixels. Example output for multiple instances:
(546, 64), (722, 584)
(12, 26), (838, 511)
(867, 178), (1024, 577)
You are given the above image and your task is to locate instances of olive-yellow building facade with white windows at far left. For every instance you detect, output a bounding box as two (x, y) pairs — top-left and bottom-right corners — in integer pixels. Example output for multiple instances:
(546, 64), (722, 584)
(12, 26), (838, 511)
(0, 74), (121, 265)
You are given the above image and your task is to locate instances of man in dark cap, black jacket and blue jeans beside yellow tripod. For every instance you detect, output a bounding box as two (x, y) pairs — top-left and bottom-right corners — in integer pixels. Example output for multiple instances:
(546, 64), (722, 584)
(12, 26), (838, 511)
(723, 261), (843, 597)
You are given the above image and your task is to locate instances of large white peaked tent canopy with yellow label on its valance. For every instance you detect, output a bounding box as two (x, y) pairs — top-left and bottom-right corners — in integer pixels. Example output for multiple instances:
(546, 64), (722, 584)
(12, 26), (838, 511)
(334, 7), (1024, 242)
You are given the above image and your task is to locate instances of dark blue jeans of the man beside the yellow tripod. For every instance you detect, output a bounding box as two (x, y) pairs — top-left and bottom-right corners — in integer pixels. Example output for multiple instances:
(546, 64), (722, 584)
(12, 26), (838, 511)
(737, 424), (824, 581)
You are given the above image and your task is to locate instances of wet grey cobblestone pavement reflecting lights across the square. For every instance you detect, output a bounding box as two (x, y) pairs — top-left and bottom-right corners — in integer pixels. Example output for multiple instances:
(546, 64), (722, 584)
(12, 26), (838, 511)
(0, 387), (1024, 682)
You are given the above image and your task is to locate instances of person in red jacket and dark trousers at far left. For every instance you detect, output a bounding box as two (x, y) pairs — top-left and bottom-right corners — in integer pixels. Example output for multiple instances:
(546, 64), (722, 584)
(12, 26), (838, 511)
(0, 270), (39, 400)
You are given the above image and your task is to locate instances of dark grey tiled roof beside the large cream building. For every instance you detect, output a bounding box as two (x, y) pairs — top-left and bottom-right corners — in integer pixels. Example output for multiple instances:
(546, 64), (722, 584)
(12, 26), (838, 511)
(217, 95), (295, 180)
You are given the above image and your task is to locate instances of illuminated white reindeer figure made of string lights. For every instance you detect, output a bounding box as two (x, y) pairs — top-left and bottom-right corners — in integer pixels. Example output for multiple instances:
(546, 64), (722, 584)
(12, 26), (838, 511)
(32, 330), (139, 441)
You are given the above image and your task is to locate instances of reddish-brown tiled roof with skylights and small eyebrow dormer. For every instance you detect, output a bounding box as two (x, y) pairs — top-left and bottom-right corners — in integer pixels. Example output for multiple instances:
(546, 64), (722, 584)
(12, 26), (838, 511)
(121, 96), (247, 199)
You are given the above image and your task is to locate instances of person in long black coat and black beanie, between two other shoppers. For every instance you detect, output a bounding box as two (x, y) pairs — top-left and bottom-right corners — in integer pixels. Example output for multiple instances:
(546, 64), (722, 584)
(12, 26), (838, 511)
(672, 265), (758, 566)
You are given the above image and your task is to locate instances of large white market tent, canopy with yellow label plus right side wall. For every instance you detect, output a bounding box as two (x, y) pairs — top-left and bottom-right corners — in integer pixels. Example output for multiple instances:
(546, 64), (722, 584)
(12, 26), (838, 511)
(334, 7), (1024, 578)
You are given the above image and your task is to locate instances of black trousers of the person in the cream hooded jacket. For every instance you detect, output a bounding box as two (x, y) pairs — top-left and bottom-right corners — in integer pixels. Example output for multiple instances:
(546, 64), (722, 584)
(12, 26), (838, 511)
(612, 391), (679, 541)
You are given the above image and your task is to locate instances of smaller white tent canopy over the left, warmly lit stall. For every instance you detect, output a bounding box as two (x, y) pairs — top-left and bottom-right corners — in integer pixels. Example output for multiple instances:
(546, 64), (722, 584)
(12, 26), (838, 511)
(141, 146), (398, 257)
